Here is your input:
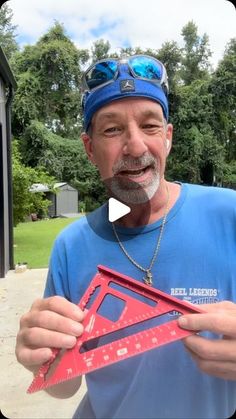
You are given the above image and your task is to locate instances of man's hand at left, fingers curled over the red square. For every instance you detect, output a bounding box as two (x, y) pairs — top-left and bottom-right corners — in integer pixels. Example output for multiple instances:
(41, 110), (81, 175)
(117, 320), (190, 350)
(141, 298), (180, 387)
(16, 296), (85, 372)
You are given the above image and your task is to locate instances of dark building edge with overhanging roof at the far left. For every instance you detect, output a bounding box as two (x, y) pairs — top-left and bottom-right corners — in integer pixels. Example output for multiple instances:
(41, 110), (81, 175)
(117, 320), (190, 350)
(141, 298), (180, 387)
(0, 47), (16, 278)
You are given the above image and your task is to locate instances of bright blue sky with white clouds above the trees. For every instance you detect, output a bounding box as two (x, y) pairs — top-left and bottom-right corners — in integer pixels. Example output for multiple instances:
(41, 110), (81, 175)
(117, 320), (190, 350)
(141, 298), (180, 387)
(8, 0), (236, 65)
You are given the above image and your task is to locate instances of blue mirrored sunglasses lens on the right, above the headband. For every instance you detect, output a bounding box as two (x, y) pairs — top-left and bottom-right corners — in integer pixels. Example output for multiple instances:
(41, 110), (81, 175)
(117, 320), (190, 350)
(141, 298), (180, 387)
(129, 57), (163, 80)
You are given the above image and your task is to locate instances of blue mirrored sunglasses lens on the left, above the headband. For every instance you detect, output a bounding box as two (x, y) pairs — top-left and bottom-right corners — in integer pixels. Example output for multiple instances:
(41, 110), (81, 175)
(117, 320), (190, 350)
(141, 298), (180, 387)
(85, 61), (117, 89)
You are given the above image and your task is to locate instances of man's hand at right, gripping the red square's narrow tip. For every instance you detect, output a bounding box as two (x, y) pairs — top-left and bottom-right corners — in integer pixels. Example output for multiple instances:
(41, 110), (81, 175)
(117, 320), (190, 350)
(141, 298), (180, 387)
(178, 301), (236, 380)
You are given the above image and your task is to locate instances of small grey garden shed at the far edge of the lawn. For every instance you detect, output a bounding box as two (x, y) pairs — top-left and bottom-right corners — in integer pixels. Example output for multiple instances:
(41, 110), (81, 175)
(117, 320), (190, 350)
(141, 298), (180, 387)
(31, 182), (78, 217)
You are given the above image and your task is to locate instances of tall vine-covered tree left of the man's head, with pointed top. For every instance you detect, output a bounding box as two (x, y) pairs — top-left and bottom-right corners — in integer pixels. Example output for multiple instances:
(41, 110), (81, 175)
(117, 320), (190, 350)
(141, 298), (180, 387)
(13, 22), (88, 138)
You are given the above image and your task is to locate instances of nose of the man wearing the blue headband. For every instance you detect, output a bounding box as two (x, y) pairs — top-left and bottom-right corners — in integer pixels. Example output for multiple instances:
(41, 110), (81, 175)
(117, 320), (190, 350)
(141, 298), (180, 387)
(123, 127), (148, 157)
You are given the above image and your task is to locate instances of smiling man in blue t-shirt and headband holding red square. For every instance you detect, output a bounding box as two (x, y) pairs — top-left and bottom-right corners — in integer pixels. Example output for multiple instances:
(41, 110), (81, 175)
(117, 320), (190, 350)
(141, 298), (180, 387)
(16, 56), (236, 419)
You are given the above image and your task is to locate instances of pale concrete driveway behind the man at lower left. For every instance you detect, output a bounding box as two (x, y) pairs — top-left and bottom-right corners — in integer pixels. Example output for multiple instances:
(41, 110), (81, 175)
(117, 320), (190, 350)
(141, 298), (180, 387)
(0, 269), (86, 419)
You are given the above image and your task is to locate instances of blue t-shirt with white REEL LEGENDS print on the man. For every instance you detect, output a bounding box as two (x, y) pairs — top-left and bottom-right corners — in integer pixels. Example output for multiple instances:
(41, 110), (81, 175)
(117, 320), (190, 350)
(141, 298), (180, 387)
(45, 184), (236, 419)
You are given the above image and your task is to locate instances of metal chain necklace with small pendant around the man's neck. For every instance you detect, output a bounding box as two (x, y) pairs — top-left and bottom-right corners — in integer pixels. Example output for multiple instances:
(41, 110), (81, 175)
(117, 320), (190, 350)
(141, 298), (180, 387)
(112, 184), (170, 286)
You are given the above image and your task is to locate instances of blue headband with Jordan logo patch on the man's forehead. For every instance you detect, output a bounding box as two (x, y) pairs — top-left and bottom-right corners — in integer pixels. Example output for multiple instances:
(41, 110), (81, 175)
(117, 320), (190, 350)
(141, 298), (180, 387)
(84, 64), (169, 132)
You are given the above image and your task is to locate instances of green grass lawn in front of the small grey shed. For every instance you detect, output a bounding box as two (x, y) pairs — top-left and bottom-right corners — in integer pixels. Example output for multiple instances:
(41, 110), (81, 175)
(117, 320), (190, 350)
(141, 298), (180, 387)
(14, 218), (82, 268)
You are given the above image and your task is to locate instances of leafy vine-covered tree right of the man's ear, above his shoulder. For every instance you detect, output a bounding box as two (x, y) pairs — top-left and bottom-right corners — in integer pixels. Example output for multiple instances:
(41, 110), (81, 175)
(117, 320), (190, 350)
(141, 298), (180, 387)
(167, 80), (224, 184)
